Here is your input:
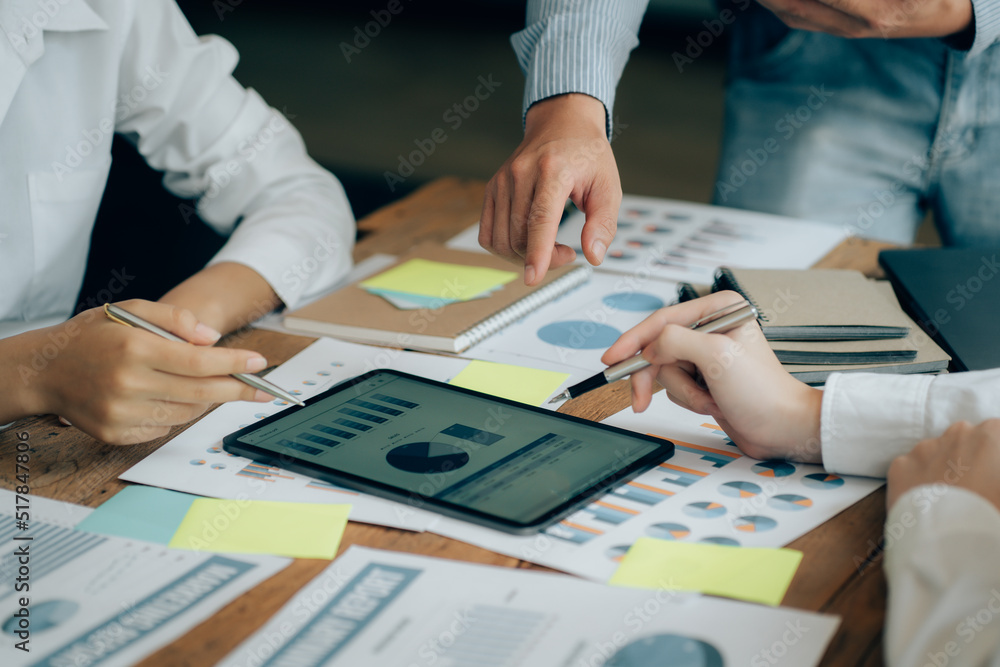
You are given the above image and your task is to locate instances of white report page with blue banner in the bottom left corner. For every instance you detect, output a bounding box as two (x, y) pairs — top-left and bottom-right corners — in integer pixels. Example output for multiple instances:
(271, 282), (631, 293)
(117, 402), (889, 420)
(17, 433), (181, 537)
(0, 494), (291, 666)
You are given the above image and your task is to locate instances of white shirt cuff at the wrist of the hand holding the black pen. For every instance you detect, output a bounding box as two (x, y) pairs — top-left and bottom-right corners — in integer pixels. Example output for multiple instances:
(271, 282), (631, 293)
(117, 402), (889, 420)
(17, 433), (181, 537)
(820, 373), (934, 477)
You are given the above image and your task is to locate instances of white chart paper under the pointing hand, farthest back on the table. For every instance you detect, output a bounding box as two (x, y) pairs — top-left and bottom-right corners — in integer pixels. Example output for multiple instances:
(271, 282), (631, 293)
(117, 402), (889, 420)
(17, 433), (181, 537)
(448, 195), (847, 284)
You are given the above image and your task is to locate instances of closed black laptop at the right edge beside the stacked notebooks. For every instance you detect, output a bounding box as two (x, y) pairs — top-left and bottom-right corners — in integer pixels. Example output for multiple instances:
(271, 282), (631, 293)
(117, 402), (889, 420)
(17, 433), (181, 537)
(878, 248), (1000, 371)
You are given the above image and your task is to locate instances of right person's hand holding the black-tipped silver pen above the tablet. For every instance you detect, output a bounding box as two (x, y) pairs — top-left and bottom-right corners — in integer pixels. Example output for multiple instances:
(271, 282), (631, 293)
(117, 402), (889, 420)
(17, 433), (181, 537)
(601, 292), (823, 463)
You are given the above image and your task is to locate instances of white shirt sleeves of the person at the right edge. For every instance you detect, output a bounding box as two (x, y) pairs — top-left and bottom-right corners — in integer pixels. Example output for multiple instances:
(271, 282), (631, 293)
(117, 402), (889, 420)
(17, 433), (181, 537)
(820, 369), (1000, 667)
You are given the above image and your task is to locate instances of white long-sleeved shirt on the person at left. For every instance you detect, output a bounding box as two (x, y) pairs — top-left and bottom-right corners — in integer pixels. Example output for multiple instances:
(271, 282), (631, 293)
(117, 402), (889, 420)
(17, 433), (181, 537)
(0, 0), (355, 338)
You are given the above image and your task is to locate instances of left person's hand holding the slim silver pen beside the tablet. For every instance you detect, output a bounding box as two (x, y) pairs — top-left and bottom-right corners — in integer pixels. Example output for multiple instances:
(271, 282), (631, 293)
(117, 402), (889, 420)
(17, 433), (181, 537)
(18, 300), (272, 444)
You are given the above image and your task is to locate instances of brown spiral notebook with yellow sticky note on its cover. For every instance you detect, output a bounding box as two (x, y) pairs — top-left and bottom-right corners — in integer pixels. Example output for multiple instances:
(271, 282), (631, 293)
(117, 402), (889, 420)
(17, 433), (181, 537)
(285, 244), (591, 352)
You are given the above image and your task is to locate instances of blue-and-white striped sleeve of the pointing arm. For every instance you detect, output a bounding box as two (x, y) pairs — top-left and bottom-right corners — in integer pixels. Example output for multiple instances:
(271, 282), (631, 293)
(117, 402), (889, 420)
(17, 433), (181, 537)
(511, 0), (648, 137)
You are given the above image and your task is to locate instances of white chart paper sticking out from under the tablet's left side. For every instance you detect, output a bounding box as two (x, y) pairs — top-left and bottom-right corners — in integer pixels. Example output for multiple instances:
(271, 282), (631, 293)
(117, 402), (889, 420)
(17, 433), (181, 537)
(121, 338), (584, 531)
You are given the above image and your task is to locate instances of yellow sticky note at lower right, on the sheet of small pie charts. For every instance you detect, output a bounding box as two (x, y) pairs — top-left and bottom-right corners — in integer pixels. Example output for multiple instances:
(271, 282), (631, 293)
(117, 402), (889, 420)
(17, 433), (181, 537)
(608, 537), (802, 606)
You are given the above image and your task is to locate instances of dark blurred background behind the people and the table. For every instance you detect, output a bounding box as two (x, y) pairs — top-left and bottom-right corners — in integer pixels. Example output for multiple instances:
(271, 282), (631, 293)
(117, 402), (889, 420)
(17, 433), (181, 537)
(80, 0), (725, 304)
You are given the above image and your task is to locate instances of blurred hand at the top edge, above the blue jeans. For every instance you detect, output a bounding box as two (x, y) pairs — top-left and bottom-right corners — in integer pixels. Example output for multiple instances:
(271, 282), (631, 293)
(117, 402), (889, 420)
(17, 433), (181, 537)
(760, 0), (972, 39)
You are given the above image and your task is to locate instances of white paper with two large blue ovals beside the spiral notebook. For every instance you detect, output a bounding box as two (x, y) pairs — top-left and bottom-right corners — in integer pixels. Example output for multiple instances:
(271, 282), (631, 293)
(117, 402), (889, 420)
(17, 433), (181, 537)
(462, 272), (677, 375)
